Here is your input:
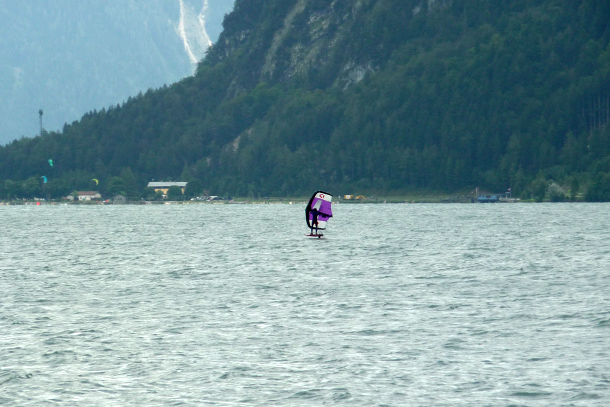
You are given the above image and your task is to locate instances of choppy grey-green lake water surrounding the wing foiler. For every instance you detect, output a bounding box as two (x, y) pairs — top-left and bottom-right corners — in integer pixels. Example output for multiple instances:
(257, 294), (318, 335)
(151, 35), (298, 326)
(0, 204), (610, 407)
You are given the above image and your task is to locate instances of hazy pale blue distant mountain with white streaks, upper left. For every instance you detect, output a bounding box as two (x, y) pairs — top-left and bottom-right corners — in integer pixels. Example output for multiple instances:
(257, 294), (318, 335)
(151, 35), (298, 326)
(0, 0), (233, 144)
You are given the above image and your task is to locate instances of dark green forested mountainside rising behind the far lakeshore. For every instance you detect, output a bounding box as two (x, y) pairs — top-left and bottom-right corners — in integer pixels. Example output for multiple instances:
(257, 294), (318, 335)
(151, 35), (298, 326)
(0, 0), (610, 200)
